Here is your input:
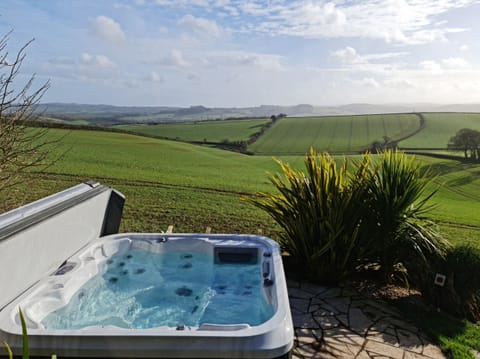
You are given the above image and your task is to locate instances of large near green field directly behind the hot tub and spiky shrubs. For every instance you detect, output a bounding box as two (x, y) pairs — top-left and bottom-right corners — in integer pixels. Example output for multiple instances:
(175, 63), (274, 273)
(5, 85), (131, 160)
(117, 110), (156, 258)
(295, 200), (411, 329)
(0, 125), (480, 245)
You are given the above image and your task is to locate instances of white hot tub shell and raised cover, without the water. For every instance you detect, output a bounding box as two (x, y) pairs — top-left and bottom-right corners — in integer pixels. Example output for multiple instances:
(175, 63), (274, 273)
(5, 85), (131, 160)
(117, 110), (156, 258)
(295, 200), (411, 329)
(0, 184), (293, 358)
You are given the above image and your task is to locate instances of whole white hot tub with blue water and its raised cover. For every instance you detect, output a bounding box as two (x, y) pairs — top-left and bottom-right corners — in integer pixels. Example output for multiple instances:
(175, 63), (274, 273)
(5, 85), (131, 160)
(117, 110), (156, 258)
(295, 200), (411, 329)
(0, 183), (293, 358)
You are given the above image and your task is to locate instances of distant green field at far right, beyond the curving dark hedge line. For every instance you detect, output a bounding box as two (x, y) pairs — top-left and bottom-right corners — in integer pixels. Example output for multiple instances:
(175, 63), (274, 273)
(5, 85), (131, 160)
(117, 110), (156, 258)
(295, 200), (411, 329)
(400, 113), (480, 149)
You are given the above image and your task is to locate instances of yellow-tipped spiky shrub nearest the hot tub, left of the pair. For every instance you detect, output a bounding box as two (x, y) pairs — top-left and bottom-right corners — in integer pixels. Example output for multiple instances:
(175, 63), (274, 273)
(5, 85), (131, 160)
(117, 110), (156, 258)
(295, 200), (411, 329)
(247, 149), (368, 283)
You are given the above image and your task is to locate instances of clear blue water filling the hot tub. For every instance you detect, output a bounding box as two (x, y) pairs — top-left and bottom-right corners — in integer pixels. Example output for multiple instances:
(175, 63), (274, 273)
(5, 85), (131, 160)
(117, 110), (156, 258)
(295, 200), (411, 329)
(42, 249), (274, 329)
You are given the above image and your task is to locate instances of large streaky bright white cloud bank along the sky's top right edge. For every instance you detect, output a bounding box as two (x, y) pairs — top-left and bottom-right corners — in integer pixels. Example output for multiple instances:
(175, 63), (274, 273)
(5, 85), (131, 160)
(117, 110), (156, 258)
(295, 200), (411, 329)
(232, 0), (477, 44)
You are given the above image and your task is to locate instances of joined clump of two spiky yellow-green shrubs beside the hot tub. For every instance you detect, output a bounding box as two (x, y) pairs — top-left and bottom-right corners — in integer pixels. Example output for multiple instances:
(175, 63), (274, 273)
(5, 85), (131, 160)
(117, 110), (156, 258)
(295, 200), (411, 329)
(248, 149), (446, 284)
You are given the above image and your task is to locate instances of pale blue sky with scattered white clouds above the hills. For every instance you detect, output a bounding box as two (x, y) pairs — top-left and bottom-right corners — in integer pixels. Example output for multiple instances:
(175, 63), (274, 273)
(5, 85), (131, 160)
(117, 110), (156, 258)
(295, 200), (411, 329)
(0, 0), (480, 107)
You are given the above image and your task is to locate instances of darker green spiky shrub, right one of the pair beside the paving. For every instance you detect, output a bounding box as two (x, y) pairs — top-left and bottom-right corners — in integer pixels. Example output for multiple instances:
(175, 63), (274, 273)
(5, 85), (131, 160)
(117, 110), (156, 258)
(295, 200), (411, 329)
(363, 150), (447, 279)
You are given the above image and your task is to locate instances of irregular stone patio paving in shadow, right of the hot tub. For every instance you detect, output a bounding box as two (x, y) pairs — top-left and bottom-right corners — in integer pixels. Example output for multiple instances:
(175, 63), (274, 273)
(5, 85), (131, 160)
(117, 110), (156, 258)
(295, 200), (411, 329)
(288, 280), (445, 359)
